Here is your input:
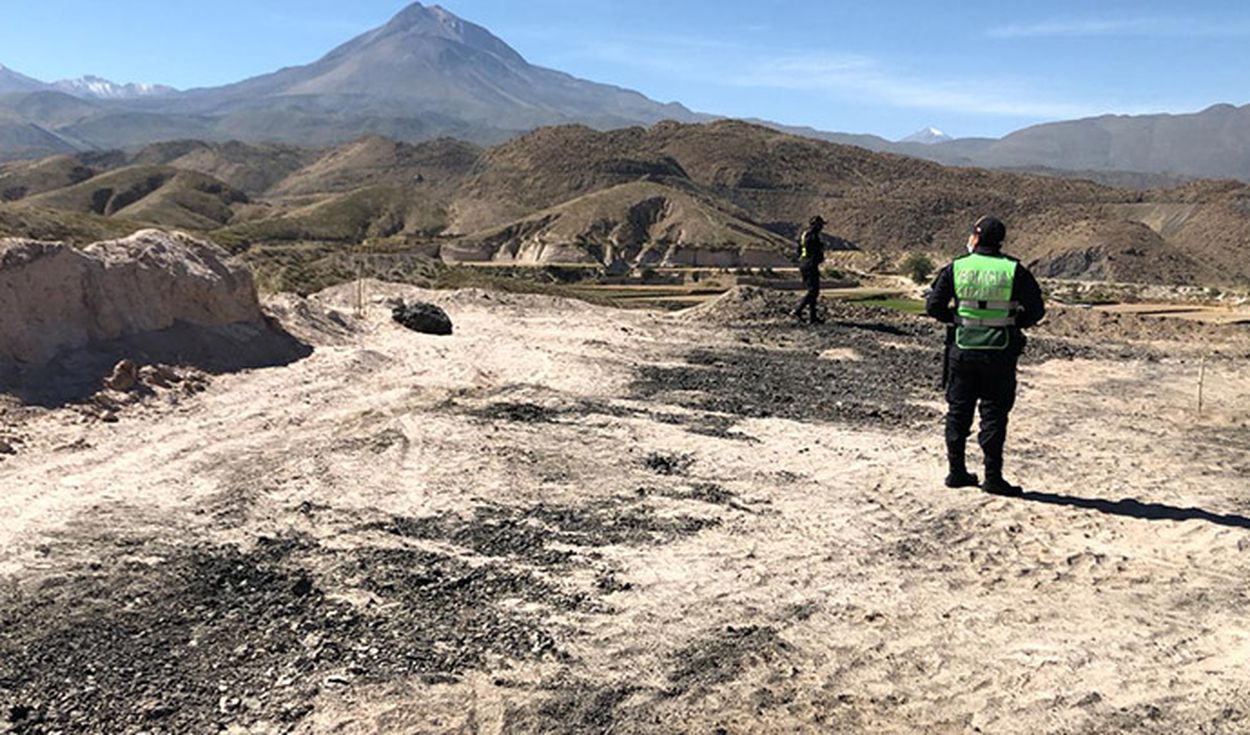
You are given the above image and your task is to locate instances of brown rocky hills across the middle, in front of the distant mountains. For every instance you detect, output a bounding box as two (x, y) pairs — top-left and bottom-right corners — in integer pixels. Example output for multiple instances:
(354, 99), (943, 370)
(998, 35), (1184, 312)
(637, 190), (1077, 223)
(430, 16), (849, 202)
(0, 121), (1250, 285)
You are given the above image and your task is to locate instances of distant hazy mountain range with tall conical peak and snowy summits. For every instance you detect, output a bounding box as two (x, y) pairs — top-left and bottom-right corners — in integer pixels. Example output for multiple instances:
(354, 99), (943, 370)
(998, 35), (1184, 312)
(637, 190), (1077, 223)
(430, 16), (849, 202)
(0, 4), (1250, 185)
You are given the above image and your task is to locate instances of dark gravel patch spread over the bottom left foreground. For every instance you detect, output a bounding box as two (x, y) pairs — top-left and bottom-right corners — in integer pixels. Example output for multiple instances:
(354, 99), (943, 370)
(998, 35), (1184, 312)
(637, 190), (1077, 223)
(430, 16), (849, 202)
(0, 530), (572, 733)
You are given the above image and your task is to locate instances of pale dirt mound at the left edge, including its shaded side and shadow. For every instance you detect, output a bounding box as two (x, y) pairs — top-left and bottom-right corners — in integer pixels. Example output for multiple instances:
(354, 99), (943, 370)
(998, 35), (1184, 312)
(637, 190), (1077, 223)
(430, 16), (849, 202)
(0, 230), (308, 395)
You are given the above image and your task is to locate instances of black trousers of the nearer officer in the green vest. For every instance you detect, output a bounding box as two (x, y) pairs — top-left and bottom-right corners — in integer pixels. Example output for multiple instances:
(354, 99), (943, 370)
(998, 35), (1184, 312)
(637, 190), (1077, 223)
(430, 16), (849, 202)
(946, 355), (1016, 478)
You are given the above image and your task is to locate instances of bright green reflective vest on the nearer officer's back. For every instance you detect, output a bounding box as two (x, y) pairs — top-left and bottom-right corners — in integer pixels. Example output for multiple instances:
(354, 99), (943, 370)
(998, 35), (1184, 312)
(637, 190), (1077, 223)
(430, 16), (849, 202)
(954, 253), (1019, 350)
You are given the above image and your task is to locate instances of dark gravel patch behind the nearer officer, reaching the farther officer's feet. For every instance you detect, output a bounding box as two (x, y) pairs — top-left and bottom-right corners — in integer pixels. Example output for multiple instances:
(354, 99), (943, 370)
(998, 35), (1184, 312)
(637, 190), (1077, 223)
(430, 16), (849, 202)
(633, 293), (1160, 429)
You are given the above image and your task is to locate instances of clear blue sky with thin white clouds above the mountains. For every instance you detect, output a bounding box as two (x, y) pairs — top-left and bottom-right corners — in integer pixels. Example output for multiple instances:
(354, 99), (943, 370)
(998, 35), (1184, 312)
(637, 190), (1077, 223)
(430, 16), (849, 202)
(0, 0), (1250, 138)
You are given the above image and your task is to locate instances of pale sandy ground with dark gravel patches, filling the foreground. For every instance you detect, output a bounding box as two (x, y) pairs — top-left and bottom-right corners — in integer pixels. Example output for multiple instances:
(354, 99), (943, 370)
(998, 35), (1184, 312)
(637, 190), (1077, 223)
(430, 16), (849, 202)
(0, 285), (1250, 733)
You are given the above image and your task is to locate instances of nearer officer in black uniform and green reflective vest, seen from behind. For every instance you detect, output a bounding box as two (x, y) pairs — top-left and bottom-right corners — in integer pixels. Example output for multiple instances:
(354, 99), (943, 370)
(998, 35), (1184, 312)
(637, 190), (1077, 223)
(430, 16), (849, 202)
(925, 218), (1046, 498)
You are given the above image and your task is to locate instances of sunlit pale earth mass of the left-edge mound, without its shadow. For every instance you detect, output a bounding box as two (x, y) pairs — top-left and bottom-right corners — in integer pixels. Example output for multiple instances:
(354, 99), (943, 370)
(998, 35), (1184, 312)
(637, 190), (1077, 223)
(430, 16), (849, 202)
(0, 230), (264, 368)
